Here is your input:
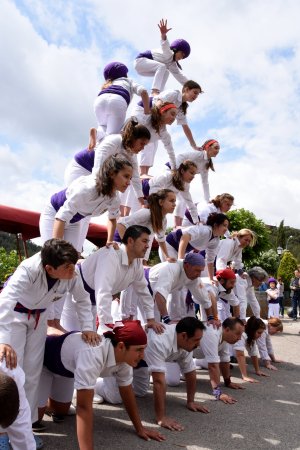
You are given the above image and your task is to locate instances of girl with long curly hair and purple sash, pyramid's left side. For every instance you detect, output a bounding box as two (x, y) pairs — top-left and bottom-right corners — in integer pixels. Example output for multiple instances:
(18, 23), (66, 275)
(40, 155), (132, 252)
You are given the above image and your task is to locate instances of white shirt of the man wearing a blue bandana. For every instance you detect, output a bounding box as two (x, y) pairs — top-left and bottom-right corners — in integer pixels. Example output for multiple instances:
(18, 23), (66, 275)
(149, 261), (211, 309)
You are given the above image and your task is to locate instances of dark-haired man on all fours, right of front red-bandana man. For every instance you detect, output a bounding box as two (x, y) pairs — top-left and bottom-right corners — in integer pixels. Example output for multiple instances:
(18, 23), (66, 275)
(145, 316), (209, 431)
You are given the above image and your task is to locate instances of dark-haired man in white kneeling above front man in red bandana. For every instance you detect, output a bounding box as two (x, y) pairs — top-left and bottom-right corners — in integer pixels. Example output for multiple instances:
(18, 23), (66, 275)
(80, 225), (164, 333)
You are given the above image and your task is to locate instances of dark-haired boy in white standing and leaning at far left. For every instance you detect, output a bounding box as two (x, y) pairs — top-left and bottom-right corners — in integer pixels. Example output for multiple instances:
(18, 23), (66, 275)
(0, 239), (99, 430)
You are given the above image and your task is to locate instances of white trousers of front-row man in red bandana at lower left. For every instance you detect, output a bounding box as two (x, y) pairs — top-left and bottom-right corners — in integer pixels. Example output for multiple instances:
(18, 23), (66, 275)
(38, 366), (74, 408)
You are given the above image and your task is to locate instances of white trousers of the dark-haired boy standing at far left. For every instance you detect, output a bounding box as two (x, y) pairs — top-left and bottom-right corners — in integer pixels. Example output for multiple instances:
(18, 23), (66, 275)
(11, 311), (47, 423)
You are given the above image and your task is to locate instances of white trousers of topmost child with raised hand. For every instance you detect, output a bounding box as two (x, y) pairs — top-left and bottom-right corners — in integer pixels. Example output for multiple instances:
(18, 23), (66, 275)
(134, 58), (170, 91)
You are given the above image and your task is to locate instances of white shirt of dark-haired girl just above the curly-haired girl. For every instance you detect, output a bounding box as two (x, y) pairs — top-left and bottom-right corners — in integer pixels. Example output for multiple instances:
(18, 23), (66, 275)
(92, 134), (144, 198)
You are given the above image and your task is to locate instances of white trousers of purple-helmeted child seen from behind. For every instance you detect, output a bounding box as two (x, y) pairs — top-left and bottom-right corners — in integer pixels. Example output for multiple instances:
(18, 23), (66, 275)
(94, 94), (127, 135)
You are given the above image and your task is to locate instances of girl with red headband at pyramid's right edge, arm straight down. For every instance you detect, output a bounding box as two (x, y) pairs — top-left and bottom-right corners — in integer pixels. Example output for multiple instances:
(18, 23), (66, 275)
(175, 139), (220, 226)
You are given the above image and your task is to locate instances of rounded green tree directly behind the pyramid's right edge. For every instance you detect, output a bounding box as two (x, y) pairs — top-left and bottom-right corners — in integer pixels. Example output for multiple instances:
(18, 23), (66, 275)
(227, 208), (271, 267)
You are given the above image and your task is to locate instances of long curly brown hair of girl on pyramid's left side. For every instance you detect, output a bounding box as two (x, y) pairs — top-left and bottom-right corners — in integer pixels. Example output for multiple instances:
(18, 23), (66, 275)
(96, 154), (132, 197)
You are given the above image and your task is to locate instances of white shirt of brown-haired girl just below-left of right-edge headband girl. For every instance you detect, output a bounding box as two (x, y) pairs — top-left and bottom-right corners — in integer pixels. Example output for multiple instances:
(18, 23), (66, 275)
(149, 171), (199, 223)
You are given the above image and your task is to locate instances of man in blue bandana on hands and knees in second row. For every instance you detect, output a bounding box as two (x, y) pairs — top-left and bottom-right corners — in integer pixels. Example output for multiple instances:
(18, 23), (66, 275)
(149, 252), (216, 325)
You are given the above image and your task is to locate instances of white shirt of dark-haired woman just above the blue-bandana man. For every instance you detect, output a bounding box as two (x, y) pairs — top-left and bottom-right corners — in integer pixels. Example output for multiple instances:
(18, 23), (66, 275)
(182, 223), (220, 263)
